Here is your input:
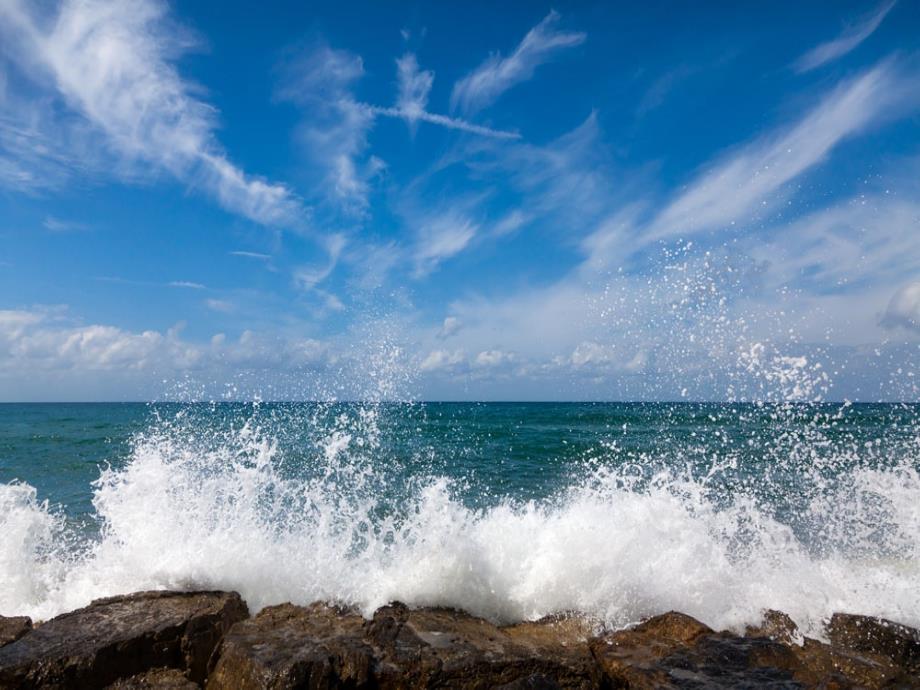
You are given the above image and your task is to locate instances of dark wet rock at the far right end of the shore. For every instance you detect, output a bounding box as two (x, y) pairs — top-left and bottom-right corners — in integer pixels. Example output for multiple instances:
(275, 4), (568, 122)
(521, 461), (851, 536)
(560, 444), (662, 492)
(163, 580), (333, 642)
(826, 613), (920, 670)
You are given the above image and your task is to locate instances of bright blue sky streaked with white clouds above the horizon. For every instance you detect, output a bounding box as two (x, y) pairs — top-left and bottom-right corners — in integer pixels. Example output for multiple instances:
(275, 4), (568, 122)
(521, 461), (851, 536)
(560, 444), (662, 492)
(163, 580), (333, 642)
(0, 0), (920, 401)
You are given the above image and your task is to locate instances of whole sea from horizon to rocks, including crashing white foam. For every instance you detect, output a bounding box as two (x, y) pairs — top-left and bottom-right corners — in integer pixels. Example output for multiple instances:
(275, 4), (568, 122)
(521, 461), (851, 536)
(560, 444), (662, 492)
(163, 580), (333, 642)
(0, 402), (920, 635)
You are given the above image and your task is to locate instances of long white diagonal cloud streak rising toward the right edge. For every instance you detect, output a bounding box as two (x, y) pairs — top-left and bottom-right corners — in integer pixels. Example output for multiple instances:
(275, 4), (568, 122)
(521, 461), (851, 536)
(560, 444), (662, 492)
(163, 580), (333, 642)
(643, 63), (917, 241)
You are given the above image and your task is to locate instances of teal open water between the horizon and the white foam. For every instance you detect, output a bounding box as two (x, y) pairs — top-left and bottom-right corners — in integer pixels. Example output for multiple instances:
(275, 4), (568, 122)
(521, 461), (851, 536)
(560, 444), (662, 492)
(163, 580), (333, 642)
(0, 403), (920, 516)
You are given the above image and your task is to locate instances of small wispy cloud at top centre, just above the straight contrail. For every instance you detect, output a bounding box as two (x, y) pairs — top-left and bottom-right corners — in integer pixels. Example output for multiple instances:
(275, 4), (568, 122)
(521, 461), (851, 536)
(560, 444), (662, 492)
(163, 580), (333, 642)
(451, 11), (587, 113)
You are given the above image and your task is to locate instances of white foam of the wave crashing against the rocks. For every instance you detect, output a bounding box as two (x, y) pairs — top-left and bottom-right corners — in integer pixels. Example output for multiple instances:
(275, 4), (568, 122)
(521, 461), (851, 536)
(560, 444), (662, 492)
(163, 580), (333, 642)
(0, 406), (920, 635)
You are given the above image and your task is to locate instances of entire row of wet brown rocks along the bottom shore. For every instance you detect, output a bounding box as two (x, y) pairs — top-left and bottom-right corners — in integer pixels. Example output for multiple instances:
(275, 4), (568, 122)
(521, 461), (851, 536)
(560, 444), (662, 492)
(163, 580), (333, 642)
(0, 592), (920, 690)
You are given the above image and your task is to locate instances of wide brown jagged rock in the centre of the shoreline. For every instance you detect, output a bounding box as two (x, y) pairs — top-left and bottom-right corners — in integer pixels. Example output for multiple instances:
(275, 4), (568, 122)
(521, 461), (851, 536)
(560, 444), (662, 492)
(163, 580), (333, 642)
(208, 604), (601, 690)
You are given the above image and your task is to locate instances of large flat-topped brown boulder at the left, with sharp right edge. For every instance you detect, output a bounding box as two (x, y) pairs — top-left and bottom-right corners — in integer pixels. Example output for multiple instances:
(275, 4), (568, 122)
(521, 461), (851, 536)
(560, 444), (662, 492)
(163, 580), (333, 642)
(0, 592), (248, 688)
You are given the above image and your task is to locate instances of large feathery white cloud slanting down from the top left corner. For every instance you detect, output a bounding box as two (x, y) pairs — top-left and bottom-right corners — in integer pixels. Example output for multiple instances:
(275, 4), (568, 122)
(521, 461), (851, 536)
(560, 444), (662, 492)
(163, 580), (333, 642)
(0, 0), (302, 225)
